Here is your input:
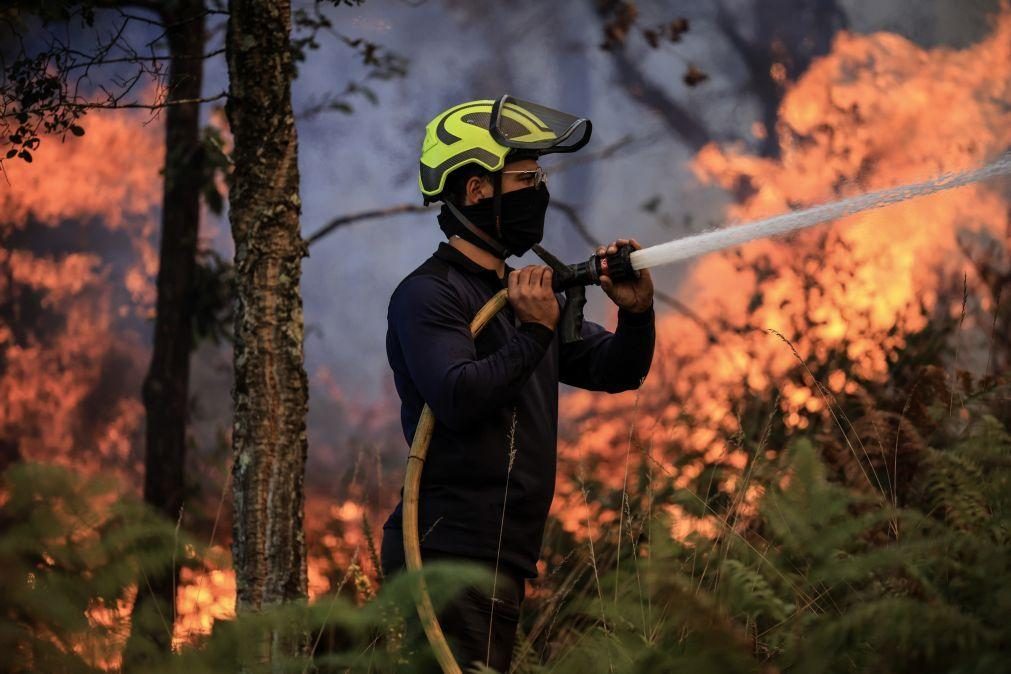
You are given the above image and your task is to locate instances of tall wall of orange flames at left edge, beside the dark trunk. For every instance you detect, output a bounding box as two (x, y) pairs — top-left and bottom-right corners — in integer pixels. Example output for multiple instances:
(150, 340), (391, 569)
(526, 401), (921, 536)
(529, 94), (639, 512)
(0, 109), (163, 472)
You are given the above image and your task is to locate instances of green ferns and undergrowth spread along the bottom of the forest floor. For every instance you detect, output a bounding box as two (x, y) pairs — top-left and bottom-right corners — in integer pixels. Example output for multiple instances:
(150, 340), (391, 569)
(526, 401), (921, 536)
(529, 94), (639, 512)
(0, 264), (1011, 674)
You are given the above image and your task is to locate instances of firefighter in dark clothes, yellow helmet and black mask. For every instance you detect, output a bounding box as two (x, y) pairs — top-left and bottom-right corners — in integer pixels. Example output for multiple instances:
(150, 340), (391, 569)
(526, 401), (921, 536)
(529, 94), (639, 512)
(381, 96), (655, 672)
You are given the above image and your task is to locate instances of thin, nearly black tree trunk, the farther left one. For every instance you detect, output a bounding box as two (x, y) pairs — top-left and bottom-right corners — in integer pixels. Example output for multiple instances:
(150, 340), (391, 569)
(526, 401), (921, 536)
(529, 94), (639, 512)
(123, 0), (204, 671)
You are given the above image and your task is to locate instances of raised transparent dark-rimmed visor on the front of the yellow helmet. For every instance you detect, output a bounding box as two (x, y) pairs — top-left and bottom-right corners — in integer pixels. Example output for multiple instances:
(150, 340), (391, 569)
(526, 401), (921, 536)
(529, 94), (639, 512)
(488, 96), (592, 155)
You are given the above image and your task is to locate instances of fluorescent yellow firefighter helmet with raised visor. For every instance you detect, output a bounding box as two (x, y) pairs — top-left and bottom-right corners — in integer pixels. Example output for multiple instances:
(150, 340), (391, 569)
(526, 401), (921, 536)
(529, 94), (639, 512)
(418, 96), (592, 203)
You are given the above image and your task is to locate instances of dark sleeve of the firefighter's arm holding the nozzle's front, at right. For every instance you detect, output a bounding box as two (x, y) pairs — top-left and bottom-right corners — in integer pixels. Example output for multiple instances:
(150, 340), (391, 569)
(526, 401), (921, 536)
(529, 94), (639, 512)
(559, 306), (656, 393)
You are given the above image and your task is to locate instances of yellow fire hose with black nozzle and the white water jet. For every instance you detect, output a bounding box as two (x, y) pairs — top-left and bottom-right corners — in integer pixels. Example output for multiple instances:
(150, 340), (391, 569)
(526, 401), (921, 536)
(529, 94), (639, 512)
(403, 153), (1011, 674)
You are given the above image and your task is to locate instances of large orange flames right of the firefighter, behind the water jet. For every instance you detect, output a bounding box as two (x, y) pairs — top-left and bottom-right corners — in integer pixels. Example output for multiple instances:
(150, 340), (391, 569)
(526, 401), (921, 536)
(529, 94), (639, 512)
(552, 6), (1011, 538)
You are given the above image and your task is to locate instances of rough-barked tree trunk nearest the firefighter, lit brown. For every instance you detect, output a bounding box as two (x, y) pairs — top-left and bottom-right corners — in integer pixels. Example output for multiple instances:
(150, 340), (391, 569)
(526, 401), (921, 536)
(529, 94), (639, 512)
(225, 0), (308, 660)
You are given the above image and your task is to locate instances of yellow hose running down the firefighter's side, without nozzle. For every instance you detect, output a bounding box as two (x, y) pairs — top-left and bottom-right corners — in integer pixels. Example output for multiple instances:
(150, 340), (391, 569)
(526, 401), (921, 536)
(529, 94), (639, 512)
(402, 290), (509, 674)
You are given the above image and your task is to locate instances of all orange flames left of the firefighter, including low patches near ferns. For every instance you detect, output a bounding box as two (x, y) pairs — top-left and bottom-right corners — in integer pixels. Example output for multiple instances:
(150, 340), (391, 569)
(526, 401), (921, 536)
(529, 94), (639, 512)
(0, 103), (378, 669)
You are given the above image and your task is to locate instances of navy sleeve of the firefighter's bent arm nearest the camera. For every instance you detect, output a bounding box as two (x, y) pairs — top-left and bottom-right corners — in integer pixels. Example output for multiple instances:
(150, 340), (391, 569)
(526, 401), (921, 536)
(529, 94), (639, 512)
(387, 276), (554, 429)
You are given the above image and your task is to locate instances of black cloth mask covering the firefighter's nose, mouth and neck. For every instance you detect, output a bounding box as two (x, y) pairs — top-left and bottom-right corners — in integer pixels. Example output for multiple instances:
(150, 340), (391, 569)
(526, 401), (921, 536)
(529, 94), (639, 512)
(439, 185), (551, 256)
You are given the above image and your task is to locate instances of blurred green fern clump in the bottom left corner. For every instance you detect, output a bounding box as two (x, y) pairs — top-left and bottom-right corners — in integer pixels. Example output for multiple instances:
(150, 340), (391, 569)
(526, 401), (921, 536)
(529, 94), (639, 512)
(0, 464), (177, 672)
